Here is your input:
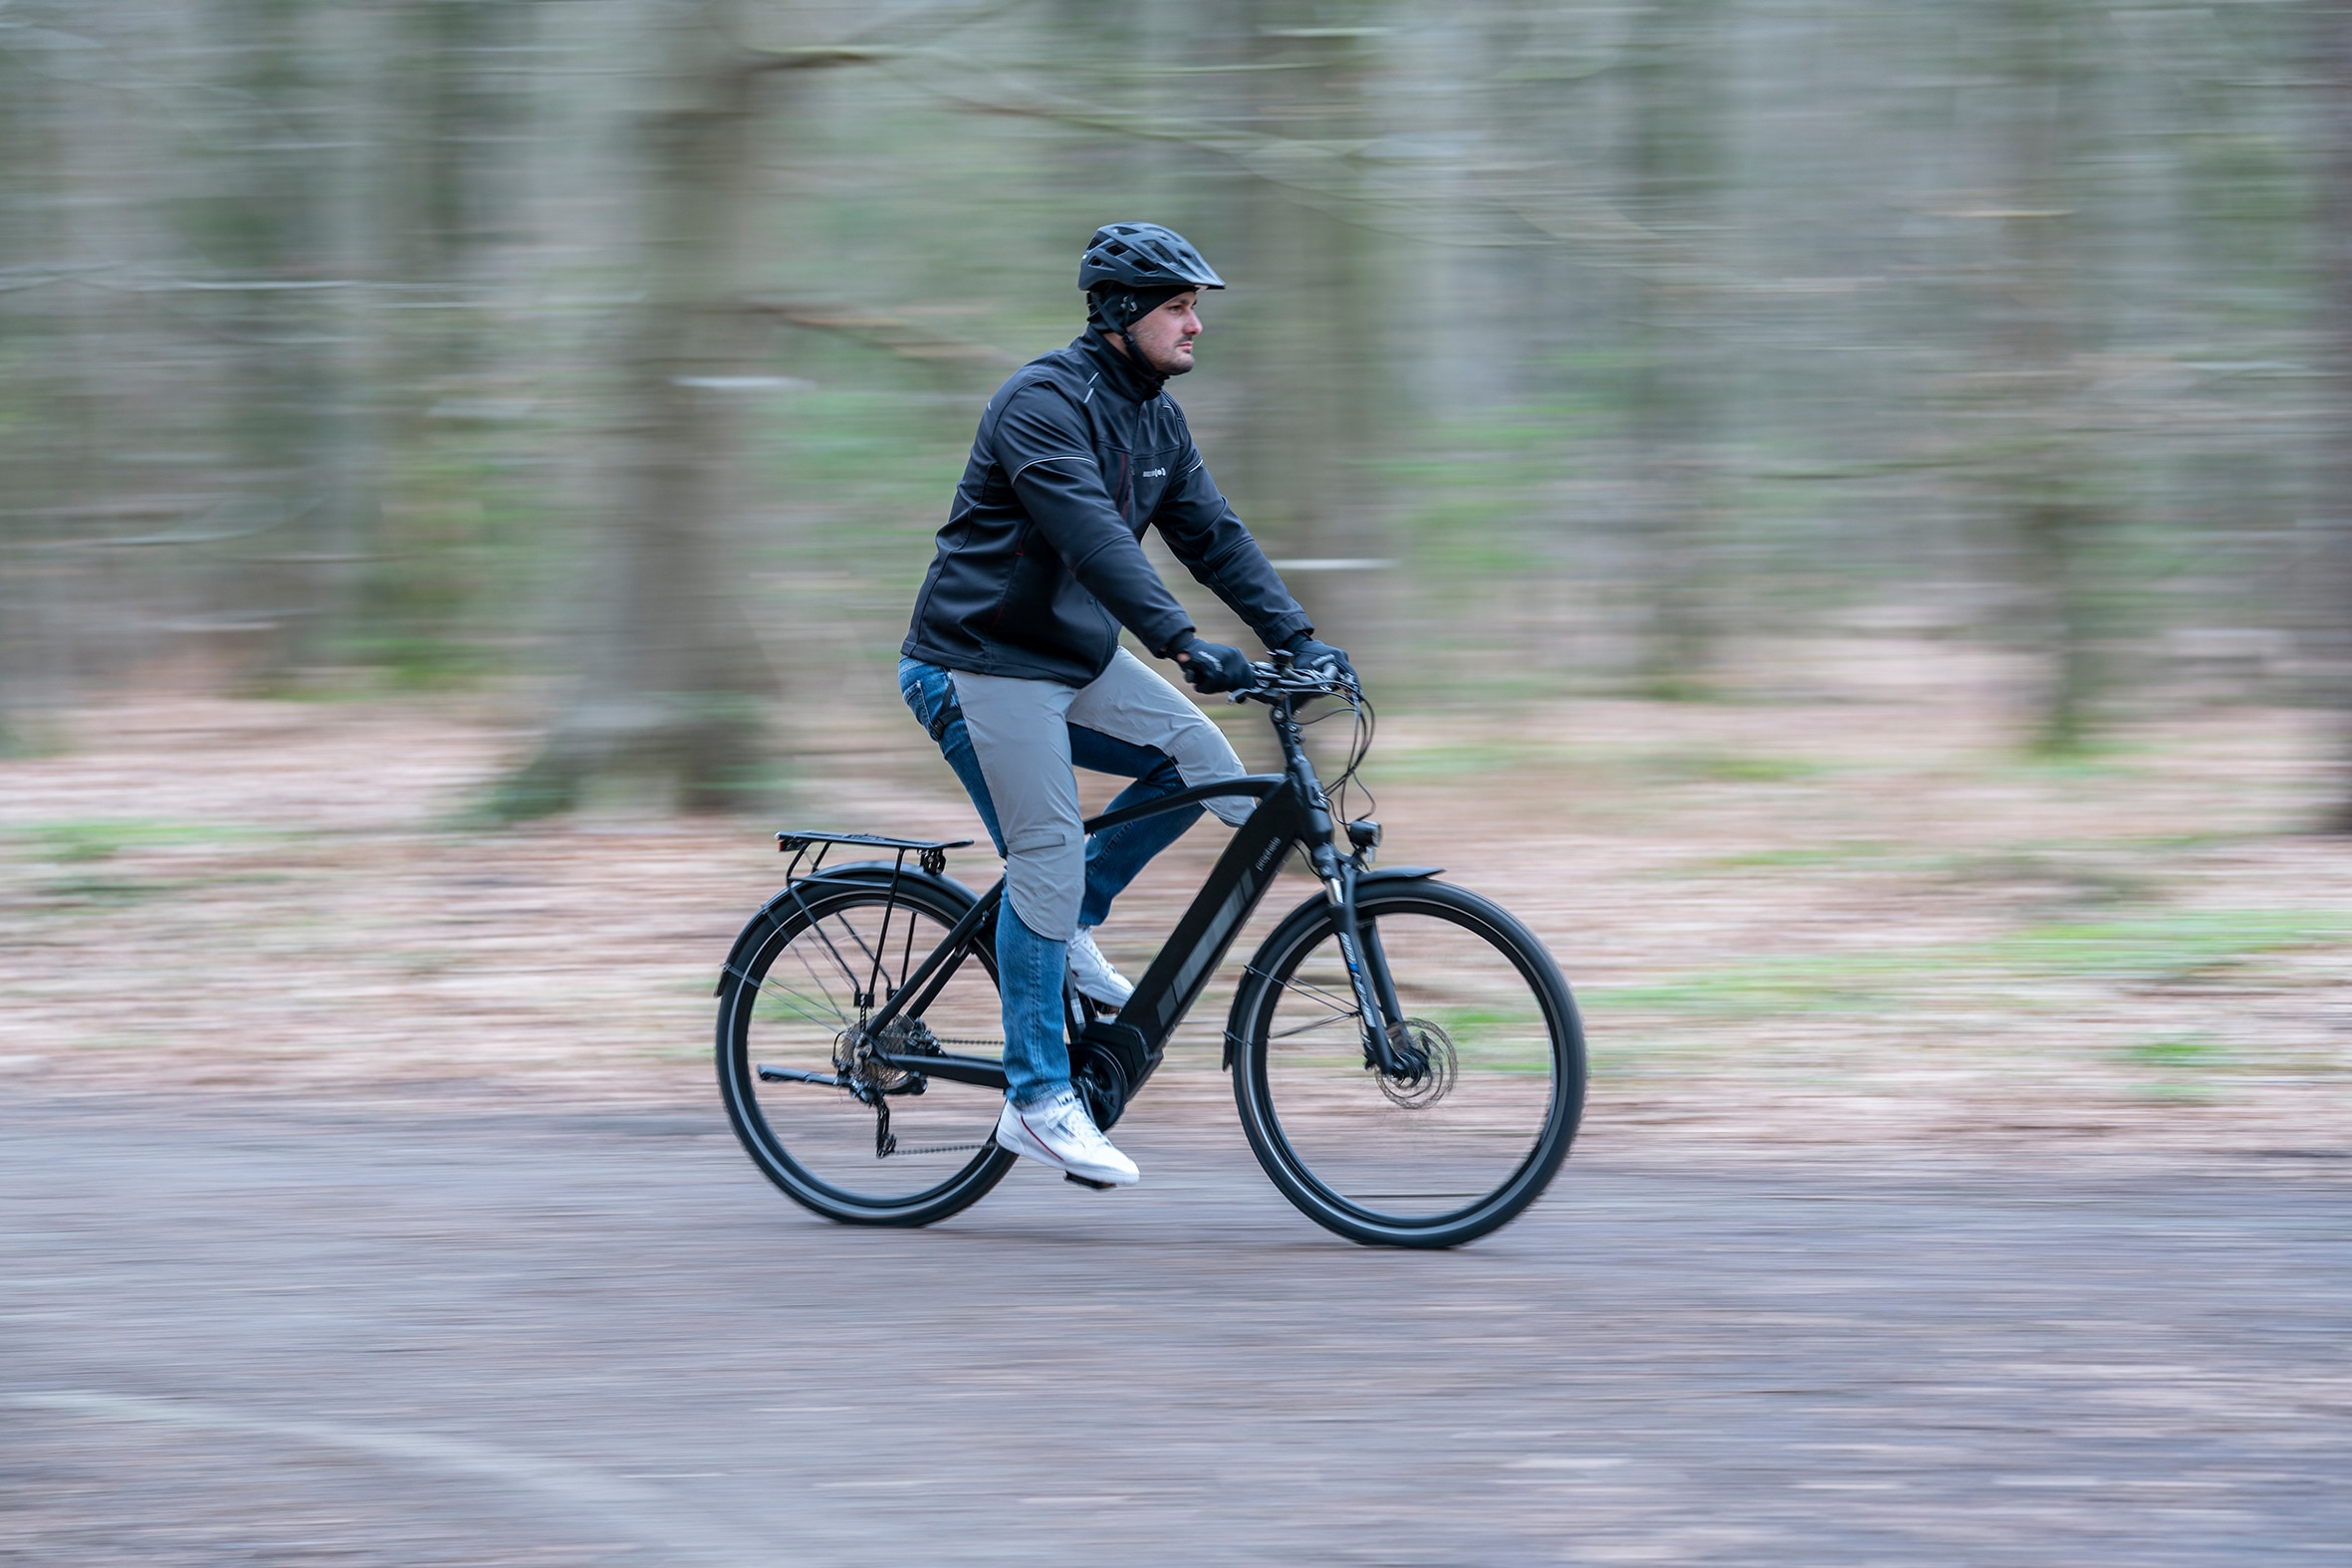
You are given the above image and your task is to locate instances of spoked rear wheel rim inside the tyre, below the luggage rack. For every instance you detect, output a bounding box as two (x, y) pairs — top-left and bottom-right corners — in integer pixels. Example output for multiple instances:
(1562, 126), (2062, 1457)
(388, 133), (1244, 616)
(729, 893), (1005, 1213)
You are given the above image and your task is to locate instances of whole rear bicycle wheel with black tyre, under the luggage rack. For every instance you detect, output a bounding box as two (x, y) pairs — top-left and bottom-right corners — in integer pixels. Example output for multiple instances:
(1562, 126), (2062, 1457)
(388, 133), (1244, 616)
(717, 877), (1014, 1225)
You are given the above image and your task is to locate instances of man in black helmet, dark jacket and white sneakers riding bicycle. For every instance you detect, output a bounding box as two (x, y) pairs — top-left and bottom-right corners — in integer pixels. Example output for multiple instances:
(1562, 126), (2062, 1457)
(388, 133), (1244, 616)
(898, 223), (1347, 1185)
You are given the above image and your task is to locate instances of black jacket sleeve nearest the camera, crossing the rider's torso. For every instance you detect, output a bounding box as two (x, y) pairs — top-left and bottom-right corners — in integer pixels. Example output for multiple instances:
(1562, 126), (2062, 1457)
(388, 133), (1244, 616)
(995, 385), (1193, 653)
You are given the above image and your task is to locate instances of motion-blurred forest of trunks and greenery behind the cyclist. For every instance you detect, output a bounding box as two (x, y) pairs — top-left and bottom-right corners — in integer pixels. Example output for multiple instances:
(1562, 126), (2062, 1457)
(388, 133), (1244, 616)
(0, 0), (2352, 827)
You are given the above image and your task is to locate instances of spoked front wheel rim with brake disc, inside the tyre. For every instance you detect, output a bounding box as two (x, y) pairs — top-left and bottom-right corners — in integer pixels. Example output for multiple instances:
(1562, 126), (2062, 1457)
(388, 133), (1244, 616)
(1252, 900), (1576, 1232)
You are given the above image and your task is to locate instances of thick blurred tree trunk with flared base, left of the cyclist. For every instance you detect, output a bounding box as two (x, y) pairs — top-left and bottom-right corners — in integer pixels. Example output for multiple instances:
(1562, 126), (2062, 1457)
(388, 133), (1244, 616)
(494, 0), (774, 815)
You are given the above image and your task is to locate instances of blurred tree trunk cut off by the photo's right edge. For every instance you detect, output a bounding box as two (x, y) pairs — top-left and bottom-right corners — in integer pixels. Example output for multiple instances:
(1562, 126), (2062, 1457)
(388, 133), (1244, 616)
(2317, 0), (2352, 832)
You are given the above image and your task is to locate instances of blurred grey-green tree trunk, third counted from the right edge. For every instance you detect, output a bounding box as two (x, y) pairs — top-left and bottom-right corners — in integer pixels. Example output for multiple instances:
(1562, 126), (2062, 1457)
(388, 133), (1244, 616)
(1623, 0), (1727, 698)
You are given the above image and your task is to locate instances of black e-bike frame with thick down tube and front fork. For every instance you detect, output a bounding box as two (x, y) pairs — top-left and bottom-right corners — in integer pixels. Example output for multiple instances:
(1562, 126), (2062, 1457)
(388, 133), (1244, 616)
(865, 694), (1414, 1100)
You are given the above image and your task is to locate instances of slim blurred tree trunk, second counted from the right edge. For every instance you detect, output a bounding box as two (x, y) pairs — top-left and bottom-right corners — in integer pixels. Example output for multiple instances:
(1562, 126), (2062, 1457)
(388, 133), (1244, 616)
(1993, 0), (2114, 753)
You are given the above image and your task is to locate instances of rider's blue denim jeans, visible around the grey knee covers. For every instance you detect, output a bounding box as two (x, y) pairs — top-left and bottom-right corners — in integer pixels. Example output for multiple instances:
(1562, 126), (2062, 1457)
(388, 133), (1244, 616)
(898, 658), (1200, 1105)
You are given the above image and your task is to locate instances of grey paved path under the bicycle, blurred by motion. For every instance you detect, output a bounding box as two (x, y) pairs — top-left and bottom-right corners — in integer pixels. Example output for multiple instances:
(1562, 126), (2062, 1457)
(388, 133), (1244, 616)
(0, 1093), (2352, 1568)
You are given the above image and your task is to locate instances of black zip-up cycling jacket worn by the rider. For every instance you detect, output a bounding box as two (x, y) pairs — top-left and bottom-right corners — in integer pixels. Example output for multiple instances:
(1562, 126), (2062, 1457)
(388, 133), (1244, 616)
(901, 332), (1312, 687)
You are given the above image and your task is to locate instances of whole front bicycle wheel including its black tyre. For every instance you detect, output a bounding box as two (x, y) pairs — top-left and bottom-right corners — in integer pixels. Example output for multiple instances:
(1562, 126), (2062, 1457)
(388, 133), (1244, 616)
(1230, 879), (1585, 1248)
